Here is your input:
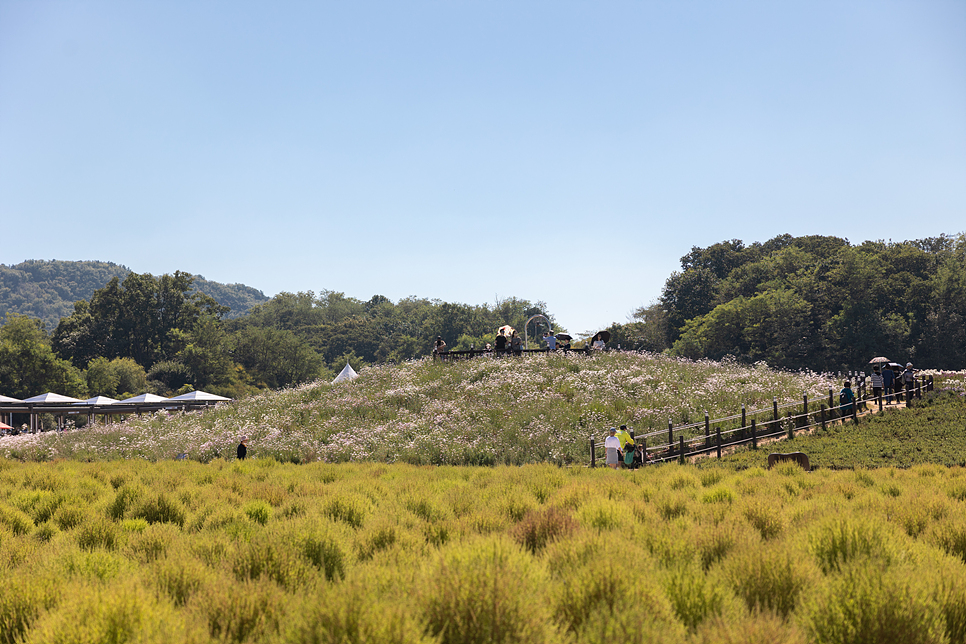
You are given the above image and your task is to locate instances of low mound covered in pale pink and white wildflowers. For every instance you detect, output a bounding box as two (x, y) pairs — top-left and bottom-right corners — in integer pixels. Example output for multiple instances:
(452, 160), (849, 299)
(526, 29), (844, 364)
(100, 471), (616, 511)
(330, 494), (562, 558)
(0, 352), (841, 465)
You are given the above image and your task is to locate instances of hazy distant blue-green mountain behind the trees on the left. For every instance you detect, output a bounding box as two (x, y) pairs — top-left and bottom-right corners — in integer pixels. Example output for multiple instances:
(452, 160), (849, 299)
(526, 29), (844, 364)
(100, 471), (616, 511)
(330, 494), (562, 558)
(0, 259), (269, 331)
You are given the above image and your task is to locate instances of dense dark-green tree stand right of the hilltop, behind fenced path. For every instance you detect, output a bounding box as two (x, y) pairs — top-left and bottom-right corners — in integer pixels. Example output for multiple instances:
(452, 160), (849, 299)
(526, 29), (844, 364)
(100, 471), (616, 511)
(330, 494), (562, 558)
(611, 234), (966, 370)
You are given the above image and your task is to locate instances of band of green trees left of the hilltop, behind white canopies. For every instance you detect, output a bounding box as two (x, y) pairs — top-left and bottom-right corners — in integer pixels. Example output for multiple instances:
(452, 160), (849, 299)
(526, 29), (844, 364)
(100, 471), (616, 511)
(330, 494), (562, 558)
(0, 271), (552, 398)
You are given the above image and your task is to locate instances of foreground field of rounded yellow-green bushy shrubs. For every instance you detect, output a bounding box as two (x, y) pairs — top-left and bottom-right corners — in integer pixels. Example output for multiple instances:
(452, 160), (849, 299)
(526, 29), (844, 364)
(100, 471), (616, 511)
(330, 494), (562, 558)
(0, 458), (966, 644)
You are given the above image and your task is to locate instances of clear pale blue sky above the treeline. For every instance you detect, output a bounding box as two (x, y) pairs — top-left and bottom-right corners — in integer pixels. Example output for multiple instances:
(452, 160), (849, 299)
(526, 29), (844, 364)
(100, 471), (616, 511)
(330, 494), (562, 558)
(0, 0), (966, 332)
